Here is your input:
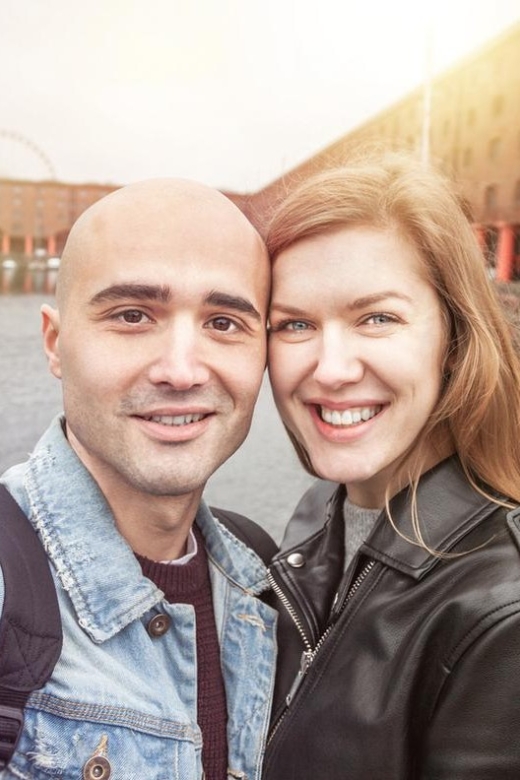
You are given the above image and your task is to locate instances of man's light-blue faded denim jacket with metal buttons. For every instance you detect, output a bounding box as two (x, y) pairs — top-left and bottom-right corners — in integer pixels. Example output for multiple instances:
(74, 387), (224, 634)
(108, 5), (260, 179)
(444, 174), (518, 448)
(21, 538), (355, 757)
(0, 418), (276, 780)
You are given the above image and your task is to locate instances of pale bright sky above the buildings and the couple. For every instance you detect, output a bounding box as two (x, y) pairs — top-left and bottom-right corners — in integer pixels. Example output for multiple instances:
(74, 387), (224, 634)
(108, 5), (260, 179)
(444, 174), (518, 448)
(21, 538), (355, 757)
(0, 0), (520, 192)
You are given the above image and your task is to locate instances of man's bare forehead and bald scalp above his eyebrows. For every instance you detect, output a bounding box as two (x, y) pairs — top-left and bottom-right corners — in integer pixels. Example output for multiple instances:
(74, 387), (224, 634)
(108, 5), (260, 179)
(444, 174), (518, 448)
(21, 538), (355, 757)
(58, 180), (267, 310)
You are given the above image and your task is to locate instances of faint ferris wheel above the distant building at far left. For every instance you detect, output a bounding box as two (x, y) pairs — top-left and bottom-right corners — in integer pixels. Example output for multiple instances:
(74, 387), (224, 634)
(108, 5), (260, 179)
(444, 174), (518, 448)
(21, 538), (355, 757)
(0, 128), (56, 181)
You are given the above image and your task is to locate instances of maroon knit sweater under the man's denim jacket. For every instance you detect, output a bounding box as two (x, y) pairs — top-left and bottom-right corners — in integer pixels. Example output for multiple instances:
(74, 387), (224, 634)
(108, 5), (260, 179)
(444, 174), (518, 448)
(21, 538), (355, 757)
(136, 526), (228, 780)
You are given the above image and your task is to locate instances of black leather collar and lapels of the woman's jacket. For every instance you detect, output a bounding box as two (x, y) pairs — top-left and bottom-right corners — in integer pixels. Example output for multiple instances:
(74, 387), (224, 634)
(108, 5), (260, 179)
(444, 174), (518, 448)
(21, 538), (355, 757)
(270, 456), (496, 644)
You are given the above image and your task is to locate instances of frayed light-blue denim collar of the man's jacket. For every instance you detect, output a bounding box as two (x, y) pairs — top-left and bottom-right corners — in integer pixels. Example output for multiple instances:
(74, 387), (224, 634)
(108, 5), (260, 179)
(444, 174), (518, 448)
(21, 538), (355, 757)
(25, 417), (267, 643)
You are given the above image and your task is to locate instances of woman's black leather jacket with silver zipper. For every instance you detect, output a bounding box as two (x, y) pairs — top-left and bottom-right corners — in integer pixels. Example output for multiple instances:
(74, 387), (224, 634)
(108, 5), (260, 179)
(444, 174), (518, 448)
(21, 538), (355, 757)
(263, 458), (520, 780)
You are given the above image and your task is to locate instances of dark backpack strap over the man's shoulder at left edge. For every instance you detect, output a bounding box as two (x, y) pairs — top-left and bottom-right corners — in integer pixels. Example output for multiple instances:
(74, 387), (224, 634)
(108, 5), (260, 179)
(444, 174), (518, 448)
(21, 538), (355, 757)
(0, 485), (62, 769)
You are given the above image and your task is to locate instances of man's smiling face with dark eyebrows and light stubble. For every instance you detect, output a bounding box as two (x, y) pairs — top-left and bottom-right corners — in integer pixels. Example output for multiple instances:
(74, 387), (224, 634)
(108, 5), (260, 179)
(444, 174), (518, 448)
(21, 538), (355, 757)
(44, 184), (269, 502)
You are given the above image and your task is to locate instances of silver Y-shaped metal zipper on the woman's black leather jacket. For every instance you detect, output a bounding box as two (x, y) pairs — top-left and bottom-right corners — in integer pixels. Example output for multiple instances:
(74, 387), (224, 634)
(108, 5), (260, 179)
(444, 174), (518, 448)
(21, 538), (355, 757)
(267, 560), (375, 743)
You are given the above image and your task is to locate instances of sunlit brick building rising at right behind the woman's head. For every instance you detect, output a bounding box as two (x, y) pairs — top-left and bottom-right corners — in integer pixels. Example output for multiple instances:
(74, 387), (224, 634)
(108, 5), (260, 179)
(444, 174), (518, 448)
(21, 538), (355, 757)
(246, 19), (520, 280)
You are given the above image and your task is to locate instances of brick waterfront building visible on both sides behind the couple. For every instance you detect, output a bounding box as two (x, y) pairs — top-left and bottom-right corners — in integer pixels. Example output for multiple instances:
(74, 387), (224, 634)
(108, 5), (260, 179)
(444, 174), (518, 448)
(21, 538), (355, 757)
(0, 23), (520, 281)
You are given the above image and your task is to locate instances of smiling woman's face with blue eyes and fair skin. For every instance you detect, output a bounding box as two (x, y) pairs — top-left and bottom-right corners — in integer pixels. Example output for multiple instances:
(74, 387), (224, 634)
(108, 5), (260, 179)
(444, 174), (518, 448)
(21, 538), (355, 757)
(269, 222), (445, 507)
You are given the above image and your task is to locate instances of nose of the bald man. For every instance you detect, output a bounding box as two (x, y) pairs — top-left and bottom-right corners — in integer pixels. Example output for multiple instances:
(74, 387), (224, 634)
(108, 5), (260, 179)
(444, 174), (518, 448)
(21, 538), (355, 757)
(149, 321), (211, 390)
